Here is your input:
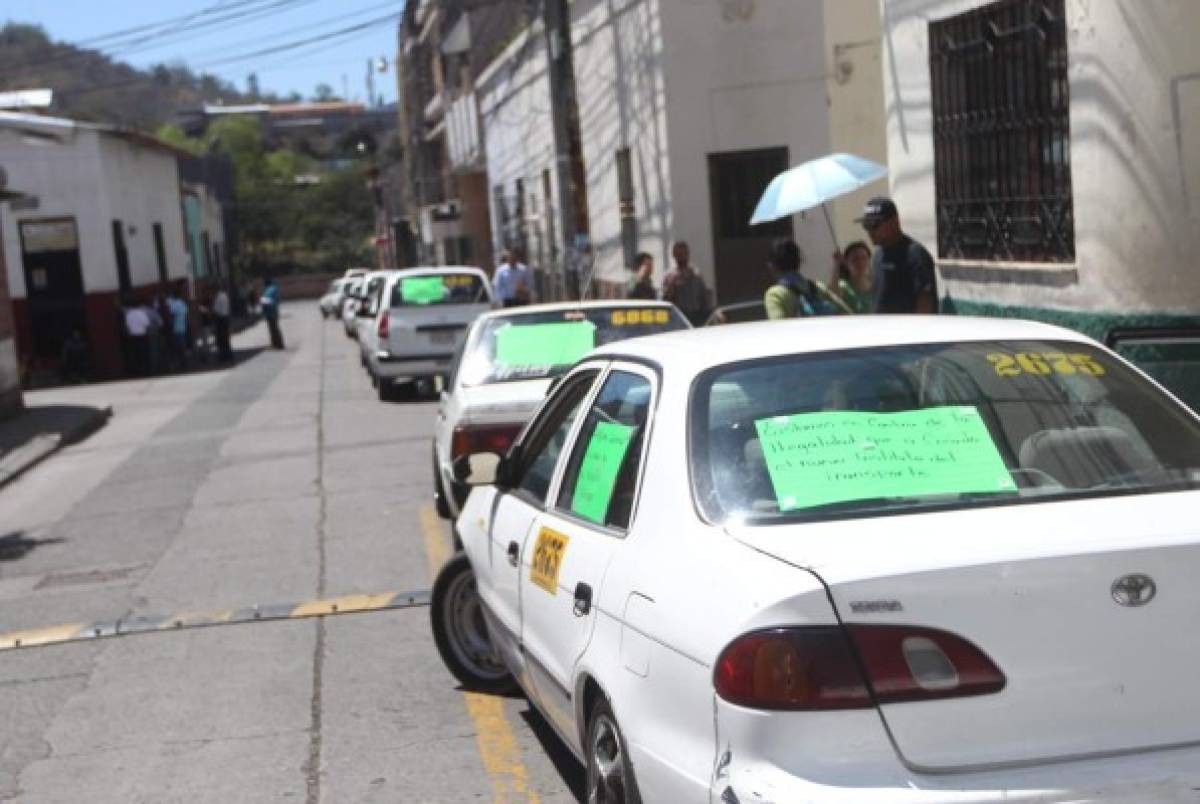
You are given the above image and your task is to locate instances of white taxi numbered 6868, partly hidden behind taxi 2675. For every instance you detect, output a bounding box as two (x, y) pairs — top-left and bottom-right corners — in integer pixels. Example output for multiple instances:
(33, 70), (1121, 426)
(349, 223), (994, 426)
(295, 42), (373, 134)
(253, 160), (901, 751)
(433, 301), (691, 518)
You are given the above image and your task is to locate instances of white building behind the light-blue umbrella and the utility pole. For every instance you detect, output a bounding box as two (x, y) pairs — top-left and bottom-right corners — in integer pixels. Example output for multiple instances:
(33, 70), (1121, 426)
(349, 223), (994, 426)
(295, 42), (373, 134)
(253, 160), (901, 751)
(476, 0), (886, 301)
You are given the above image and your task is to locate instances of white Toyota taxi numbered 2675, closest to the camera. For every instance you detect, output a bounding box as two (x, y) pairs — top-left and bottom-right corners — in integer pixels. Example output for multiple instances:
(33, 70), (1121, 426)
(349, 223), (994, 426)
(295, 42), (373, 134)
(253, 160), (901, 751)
(432, 317), (1200, 804)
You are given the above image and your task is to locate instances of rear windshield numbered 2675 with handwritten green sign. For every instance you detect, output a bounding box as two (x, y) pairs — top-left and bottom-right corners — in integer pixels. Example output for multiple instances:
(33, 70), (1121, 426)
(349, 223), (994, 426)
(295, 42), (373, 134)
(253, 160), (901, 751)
(691, 341), (1200, 523)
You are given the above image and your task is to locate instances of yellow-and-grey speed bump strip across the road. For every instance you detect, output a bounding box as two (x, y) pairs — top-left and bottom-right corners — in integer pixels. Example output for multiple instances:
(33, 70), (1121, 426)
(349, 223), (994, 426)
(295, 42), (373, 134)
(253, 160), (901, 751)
(0, 589), (431, 650)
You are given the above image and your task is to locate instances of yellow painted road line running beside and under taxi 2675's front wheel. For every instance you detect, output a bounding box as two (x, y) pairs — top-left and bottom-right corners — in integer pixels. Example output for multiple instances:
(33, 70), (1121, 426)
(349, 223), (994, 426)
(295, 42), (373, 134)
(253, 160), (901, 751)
(418, 505), (539, 804)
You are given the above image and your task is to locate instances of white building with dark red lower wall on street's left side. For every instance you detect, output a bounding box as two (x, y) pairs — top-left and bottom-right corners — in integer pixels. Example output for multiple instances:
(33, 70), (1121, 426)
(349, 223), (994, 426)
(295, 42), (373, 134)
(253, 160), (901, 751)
(0, 113), (188, 377)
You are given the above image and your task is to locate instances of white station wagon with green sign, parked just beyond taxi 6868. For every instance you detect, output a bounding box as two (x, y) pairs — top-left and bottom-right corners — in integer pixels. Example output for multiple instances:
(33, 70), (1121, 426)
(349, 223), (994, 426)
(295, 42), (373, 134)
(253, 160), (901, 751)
(359, 268), (493, 400)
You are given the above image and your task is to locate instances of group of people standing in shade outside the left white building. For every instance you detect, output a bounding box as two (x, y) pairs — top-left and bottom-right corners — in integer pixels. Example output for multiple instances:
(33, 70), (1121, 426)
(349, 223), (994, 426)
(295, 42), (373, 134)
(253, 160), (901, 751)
(120, 287), (233, 377)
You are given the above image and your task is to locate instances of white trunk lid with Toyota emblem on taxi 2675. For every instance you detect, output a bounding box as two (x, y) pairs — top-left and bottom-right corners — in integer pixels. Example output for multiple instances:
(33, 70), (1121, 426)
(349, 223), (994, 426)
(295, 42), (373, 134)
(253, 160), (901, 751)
(730, 492), (1200, 770)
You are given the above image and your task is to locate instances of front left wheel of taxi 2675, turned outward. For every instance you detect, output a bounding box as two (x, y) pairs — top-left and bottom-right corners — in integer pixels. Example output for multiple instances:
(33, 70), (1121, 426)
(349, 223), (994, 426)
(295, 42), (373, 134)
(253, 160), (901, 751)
(430, 553), (516, 695)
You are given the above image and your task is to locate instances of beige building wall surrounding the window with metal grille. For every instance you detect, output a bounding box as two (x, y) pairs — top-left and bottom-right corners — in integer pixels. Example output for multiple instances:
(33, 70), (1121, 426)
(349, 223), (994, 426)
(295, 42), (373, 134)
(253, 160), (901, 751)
(883, 0), (1200, 314)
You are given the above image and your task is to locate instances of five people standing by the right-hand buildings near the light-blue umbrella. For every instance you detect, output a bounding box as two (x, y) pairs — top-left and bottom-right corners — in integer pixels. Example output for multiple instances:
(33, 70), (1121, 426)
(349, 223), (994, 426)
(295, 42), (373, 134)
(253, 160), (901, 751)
(628, 198), (937, 326)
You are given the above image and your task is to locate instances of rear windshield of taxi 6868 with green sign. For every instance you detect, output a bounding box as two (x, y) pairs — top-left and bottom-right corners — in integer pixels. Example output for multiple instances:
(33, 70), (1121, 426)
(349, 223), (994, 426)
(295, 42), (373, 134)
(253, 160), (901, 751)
(462, 305), (688, 385)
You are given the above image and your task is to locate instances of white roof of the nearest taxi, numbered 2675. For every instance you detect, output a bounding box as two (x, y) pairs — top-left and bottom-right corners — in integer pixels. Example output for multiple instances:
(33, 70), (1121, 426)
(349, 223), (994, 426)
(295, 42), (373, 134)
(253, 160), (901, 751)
(589, 316), (1094, 374)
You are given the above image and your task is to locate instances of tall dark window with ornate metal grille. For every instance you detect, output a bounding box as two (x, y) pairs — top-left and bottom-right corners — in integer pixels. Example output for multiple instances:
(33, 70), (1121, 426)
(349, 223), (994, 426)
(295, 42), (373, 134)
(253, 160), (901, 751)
(929, 0), (1075, 263)
